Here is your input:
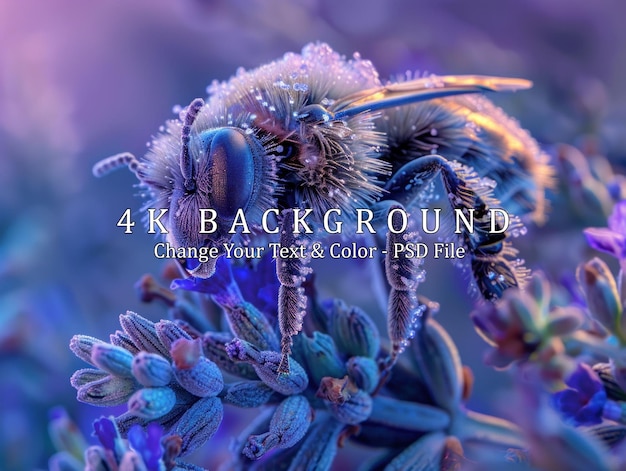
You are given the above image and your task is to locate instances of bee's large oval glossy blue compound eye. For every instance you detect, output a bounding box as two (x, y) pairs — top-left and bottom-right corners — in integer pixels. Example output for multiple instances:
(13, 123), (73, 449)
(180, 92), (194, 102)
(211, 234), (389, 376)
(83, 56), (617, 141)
(209, 128), (255, 218)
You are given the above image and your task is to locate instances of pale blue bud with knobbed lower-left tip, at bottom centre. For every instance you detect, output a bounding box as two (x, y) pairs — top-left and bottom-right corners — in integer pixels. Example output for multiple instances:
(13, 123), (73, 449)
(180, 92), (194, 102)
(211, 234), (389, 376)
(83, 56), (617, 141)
(243, 396), (313, 460)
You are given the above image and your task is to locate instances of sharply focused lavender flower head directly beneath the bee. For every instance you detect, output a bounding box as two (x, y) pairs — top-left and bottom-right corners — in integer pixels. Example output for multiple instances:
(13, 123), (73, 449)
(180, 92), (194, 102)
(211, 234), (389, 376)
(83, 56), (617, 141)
(59, 254), (522, 469)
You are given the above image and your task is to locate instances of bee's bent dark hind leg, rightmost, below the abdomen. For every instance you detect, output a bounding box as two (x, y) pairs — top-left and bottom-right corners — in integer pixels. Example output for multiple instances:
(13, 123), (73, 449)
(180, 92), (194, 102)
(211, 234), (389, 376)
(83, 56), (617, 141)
(385, 155), (528, 300)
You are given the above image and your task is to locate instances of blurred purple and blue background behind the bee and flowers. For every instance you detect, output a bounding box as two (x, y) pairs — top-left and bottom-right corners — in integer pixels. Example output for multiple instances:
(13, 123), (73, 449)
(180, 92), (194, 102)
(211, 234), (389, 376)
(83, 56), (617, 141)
(0, 0), (626, 470)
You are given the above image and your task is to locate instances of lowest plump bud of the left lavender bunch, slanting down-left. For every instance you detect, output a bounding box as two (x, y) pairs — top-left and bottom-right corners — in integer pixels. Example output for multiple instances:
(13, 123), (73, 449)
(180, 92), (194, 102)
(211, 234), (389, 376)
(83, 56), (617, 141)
(170, 397), (224, 456)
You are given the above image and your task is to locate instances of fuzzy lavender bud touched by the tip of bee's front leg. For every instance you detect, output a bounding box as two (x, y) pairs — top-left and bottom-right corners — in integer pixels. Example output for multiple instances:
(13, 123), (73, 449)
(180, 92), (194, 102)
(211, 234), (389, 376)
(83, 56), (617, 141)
(226, 339), (309, 395)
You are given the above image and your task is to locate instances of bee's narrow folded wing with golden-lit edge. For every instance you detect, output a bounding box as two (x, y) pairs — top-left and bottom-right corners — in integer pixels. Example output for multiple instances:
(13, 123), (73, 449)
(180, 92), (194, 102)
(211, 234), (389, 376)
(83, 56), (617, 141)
(331, 75), (532, 119)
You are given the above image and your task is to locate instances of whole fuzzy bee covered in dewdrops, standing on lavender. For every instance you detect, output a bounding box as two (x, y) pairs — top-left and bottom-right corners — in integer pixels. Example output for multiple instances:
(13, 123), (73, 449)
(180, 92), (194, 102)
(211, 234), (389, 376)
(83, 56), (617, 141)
(94, 43), (552, 372)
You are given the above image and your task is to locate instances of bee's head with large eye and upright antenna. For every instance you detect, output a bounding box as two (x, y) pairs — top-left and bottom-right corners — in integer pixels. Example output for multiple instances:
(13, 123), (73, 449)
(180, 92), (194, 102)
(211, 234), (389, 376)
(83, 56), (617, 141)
(168, 99), (264, 278)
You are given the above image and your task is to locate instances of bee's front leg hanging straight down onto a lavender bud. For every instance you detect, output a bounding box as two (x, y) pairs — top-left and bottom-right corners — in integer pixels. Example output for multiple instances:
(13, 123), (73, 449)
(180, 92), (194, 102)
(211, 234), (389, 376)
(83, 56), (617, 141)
(276, 209), (309, 374)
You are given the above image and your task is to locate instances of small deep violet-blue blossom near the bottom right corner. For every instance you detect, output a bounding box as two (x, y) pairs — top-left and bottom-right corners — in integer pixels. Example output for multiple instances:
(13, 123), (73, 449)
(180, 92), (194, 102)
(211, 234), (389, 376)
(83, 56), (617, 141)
(553, 363), (607, 425)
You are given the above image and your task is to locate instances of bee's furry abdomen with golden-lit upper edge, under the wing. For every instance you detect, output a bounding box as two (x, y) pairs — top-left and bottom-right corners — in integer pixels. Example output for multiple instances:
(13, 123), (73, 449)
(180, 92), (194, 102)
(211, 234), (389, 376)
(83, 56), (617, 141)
(380, 95), (553, 222)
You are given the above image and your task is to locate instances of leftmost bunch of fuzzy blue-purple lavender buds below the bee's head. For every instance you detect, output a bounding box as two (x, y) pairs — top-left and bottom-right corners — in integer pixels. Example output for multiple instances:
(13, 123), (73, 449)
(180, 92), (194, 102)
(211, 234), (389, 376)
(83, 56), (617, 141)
(70, 312), (223, 455)
